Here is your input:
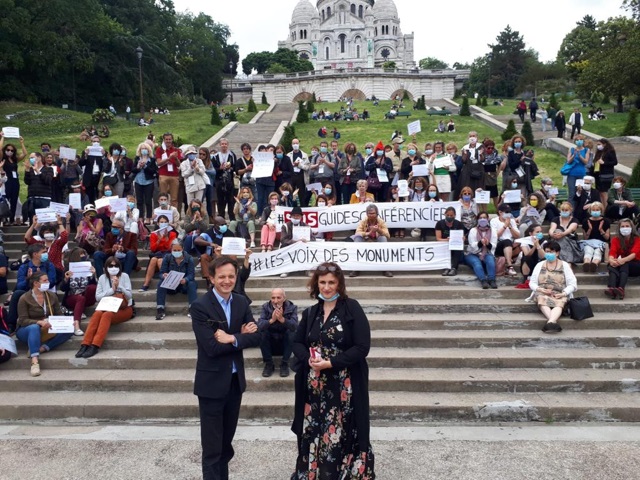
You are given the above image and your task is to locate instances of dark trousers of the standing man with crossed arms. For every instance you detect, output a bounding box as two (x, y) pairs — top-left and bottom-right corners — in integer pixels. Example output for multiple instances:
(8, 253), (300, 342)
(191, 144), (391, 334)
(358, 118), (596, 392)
(198, 374), (242, 480)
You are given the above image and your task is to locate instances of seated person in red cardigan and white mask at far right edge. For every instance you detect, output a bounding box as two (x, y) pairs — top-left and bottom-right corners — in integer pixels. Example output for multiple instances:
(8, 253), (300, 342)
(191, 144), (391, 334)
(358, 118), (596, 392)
(604, 218), (640, 300)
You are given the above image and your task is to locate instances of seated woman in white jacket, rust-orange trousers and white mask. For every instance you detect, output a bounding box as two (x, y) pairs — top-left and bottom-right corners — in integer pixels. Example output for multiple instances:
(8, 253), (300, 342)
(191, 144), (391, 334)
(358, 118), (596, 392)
(76, 257), (133, 358)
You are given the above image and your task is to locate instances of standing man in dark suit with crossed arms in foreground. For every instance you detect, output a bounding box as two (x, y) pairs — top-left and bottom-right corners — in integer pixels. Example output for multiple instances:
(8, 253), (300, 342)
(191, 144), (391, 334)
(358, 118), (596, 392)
(190, 257), (260, 480)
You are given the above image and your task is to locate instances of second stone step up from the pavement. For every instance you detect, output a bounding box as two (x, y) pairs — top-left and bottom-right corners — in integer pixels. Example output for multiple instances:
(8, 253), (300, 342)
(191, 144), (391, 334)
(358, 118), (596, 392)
(0, 368), (640, 393)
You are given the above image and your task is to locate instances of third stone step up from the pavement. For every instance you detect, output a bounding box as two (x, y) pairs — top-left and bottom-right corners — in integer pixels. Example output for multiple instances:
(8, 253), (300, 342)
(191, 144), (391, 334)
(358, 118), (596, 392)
(0, 346), (640, 370)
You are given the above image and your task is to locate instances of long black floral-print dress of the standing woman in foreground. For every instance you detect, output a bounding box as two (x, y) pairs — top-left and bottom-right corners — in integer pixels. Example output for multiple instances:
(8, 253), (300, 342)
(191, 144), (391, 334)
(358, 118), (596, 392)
(292, 309), (375, 480)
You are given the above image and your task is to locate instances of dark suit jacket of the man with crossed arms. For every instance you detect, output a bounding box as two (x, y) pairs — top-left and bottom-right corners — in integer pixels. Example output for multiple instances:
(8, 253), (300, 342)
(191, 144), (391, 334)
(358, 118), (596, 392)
(190, 290), (261, 398)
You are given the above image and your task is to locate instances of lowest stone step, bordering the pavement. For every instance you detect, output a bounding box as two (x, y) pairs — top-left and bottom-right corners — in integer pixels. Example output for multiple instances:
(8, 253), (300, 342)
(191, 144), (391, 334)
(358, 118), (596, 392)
(0, 391), (640, 422)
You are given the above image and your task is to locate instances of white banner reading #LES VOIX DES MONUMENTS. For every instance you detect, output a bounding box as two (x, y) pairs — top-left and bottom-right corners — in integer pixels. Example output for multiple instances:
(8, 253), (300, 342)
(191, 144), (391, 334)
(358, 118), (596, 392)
(250, 242), (451, 277)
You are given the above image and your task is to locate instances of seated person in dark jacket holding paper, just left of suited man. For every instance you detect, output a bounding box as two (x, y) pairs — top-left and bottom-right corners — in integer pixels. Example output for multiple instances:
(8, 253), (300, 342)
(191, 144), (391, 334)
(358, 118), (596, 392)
(156, 239), (198, 320)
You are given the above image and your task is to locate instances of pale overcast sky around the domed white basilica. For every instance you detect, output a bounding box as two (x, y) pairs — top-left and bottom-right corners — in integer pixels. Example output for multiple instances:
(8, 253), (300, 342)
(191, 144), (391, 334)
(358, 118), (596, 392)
(174, 0), (626, 70)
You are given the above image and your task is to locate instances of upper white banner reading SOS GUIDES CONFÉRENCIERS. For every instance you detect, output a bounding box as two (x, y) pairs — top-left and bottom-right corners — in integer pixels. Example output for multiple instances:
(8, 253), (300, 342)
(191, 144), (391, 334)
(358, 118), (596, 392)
(276, 202), (460, 232)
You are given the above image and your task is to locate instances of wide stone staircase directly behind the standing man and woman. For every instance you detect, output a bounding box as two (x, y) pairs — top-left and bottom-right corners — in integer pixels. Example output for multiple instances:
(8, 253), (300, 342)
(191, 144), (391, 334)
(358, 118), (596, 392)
(0, 223), (640, 423)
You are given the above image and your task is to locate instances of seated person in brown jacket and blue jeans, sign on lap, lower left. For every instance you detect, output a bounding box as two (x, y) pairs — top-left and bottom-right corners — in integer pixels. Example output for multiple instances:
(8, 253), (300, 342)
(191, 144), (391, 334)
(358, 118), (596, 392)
(16, 273), (73, 377)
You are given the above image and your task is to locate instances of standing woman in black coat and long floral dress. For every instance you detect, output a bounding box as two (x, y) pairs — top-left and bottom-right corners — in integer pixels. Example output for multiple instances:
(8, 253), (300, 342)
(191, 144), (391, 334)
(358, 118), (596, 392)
(291, 263), (375, 480)
